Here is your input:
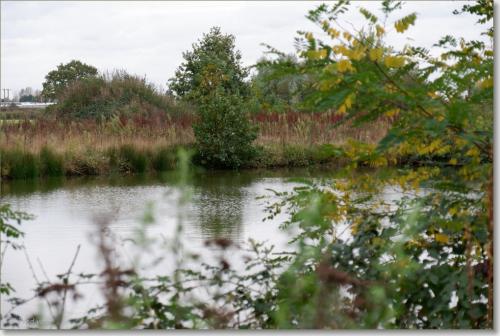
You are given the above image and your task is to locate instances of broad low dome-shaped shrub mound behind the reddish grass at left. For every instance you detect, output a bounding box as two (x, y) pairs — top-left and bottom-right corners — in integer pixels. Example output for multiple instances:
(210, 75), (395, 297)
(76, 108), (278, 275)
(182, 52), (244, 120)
(49, 71), (176, 120)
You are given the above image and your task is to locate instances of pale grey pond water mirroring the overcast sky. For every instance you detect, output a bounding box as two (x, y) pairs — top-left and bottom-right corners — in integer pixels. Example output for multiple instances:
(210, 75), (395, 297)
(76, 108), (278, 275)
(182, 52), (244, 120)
(1, 170), (336, 326)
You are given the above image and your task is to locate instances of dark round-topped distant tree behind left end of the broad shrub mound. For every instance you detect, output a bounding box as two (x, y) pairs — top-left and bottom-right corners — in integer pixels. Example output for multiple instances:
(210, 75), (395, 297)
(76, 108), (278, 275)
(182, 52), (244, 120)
(42, 60), (97, 99)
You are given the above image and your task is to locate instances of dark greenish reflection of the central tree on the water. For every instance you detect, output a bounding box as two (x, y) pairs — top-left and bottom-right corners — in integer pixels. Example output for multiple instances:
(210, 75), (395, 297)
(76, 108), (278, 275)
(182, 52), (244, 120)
(192, 171), (253, 241)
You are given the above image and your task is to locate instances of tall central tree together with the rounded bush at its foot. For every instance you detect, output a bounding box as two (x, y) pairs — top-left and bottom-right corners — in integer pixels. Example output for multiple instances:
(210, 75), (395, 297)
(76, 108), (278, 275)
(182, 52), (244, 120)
(170, 27), (256, 168)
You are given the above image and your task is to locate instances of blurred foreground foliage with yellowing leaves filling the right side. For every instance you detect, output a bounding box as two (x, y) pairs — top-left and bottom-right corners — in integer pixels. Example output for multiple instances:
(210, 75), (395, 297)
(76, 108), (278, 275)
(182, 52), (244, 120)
(260, 1), (493, 328)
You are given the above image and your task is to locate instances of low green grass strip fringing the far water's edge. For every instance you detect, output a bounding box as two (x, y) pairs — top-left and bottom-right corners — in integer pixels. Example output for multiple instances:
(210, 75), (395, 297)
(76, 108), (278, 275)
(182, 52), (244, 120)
(0, 144), (345, 179)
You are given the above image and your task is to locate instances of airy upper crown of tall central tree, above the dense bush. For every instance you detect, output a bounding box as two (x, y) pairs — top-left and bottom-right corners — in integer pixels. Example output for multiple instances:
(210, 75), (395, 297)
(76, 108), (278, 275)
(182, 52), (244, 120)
(169, 27), (248, 103)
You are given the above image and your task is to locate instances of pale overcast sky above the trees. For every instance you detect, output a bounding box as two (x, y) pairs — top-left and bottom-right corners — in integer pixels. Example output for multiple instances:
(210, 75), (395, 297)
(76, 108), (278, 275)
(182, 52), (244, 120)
(0, 1), (488, 97)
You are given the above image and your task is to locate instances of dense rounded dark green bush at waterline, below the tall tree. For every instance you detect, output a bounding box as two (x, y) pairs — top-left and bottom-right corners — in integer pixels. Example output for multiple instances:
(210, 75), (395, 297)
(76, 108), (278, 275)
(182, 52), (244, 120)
(193, 87), (257, 168)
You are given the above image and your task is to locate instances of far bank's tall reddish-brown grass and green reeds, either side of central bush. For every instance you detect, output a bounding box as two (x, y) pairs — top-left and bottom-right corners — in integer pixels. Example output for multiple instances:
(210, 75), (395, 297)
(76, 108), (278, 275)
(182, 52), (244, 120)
(0, 112), (389, 178)
